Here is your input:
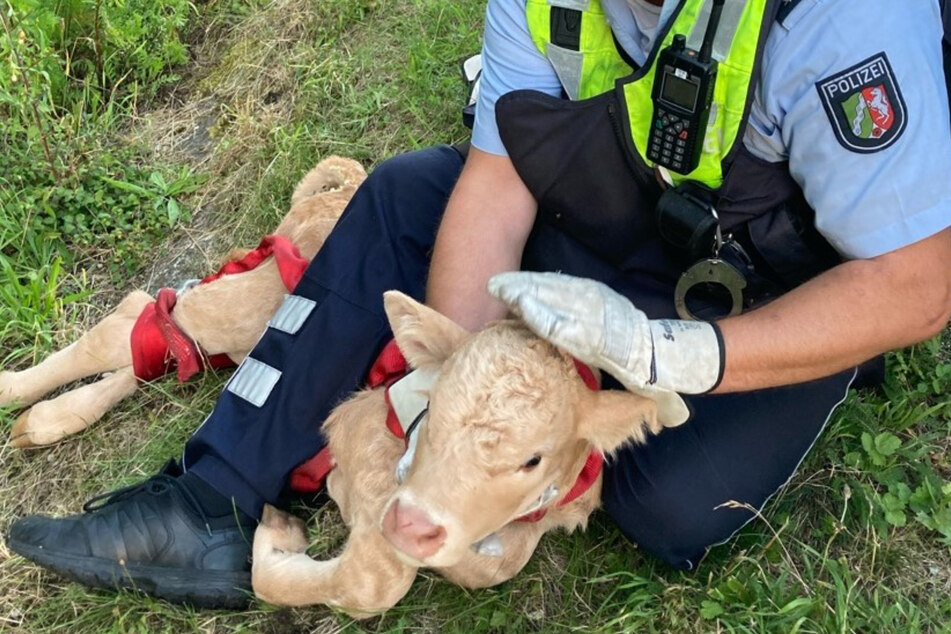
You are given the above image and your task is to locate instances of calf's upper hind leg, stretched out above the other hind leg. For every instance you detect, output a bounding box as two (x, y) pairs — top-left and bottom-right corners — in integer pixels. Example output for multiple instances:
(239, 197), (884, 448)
(0, 291), (152, 407)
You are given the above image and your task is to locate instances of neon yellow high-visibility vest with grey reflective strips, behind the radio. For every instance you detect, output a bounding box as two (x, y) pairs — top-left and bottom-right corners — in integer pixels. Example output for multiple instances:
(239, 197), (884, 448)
(525, 0), (779, 189)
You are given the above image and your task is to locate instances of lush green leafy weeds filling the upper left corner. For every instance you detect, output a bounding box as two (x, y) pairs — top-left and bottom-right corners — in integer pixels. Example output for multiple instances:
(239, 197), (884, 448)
(0, 0), (203, 366)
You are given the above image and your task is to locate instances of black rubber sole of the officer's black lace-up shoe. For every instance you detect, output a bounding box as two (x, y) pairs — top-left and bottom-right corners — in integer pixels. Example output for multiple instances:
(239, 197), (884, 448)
(7, 538), (253, 609)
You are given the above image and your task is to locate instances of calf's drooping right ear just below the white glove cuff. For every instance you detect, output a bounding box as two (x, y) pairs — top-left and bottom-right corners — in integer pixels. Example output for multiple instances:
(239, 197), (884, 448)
(577, 388), (664, 454)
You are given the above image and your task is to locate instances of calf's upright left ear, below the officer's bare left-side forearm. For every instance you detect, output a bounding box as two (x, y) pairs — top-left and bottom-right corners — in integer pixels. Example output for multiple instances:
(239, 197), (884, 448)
(383, 291), (469, 368)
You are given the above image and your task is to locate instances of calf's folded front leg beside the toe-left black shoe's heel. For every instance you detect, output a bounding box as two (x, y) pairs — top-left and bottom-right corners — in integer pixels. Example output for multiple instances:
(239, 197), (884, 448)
(251, 506), (416, 618)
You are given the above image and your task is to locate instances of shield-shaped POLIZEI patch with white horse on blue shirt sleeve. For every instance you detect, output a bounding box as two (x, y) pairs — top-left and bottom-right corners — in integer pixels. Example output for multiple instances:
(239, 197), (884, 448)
(816, 53), (906, 154)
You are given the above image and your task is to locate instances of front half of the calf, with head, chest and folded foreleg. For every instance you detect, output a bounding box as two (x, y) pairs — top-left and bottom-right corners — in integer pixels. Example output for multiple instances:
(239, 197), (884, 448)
(252, 292), (676, 617)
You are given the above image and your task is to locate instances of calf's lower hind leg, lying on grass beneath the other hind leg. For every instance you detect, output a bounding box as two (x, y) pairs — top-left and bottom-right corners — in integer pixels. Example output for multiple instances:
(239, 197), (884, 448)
(10, 366), (138, 448)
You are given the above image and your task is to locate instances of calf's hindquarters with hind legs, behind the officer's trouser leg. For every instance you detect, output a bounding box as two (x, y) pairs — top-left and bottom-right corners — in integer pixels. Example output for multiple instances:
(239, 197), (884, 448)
(0, 157), (366, 447)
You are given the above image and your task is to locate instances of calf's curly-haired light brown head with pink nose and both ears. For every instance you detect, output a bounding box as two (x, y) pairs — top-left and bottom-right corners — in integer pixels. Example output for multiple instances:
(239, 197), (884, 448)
(381, 292), (659, 567)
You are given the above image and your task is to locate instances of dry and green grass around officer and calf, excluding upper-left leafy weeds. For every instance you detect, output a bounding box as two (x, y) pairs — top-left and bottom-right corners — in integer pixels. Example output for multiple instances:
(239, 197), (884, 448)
(0, 0), (951, 634)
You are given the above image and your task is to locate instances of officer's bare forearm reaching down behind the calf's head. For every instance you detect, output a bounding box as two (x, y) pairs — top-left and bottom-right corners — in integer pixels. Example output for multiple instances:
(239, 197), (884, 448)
(426, 148), (536, 330)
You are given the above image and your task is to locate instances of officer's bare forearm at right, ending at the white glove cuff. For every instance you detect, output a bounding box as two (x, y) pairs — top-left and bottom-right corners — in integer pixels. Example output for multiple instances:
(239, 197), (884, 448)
(716, 225), (951, 392)
